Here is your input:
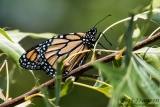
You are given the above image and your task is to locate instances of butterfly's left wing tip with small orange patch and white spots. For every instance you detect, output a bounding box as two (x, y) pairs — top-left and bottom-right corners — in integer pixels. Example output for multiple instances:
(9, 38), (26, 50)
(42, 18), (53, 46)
(19, 38), (52, 70)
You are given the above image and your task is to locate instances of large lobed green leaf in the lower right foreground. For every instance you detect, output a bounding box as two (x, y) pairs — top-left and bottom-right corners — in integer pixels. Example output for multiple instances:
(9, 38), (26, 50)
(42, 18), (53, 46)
(93, 52), (160, 107)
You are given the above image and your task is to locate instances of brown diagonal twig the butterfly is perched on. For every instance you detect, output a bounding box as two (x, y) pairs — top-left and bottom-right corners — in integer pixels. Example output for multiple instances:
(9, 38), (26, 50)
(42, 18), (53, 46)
(0, 32), (160, 107)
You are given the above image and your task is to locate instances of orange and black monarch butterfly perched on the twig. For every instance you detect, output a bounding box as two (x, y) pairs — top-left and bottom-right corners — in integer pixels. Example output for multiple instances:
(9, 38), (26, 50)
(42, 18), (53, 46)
(19, 15), (110, 77)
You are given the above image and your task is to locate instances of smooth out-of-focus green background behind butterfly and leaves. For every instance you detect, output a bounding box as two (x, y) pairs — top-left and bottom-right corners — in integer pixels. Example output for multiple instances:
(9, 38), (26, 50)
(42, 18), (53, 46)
(0, 0), (157, 107)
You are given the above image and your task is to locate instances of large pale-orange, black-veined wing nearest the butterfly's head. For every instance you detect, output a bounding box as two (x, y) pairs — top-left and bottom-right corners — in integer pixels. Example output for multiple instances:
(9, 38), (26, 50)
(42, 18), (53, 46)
(42, 35), (87, 77)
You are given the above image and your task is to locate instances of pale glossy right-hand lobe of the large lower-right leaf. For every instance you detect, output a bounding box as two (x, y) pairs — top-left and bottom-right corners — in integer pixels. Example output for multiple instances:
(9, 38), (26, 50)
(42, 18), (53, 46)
(133, 55), (160, 99)
